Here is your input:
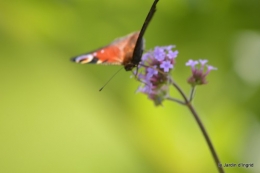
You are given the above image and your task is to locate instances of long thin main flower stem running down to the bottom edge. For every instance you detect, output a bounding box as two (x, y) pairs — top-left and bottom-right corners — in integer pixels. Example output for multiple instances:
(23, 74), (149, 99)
(170, 79), (225, 173)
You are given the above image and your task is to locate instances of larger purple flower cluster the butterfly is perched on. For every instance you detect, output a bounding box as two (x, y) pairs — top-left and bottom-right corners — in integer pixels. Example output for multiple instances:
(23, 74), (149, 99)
(137, 45), (178, 105)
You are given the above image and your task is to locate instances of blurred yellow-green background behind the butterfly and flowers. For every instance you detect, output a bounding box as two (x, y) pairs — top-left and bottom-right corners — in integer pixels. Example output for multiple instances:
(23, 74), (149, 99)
(0, 0), (260, 173)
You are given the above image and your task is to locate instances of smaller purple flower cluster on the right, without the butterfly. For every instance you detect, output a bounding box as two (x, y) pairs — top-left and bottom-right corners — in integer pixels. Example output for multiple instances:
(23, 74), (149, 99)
(186, 60), (217, 86)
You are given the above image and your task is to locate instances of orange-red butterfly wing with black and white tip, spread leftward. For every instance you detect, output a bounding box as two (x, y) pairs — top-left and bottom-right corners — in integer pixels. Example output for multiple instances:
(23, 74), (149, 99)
(72, 32), (139, 65)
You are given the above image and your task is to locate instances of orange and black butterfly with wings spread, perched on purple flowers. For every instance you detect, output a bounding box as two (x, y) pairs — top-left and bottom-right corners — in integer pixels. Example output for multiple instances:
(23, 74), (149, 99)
(71, 0), (159, 71)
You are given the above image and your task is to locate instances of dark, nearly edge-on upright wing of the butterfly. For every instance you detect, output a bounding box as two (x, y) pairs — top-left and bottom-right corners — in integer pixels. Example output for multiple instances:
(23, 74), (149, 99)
(131, 0), (159, 65)
